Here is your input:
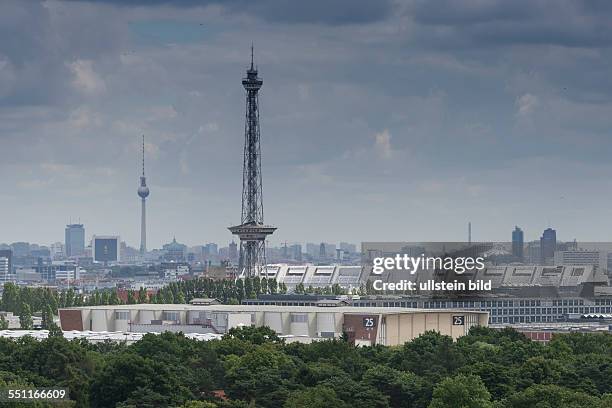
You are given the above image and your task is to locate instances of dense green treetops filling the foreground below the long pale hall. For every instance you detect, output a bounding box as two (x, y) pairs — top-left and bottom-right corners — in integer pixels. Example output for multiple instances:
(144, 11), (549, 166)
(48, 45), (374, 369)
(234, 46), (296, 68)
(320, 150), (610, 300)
(0, 327), (612, 408)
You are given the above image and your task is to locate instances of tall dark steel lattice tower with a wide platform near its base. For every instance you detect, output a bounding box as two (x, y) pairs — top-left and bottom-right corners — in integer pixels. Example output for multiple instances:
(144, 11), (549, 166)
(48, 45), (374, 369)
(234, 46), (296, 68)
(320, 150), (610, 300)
(229, 45), (276, 276)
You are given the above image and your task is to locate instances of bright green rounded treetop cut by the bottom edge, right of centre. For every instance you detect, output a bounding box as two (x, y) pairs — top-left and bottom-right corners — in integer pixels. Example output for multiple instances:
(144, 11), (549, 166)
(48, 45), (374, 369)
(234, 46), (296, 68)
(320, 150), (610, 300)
(428, 374), (493, 408)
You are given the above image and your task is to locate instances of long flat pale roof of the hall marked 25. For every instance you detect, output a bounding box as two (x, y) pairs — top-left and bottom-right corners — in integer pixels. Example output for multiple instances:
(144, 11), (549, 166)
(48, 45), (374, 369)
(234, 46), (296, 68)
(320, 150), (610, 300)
(60, 303), (489, 314)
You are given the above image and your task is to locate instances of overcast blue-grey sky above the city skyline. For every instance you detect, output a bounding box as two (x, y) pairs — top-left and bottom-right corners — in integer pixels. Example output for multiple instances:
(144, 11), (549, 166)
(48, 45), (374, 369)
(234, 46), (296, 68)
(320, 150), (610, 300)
(0, 0), (612, 248)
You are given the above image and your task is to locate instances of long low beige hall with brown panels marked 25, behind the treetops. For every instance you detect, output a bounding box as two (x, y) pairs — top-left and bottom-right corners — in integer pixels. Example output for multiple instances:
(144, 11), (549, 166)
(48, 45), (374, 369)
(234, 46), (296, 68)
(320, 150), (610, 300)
(59, 300), (489, 346)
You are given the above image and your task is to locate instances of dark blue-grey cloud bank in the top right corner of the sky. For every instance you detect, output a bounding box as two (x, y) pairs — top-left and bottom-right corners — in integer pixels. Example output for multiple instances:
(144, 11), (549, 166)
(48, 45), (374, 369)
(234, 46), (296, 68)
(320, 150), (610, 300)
(407, 0), (612, 48)
